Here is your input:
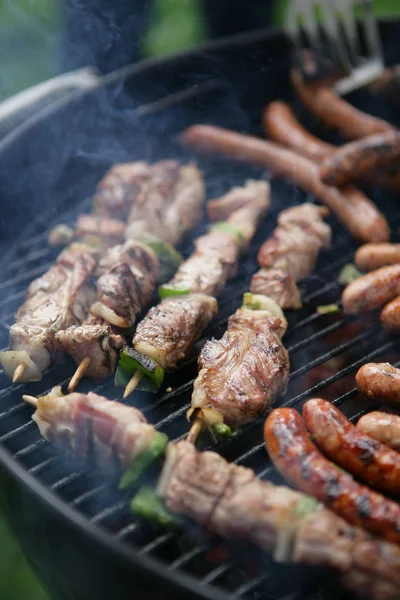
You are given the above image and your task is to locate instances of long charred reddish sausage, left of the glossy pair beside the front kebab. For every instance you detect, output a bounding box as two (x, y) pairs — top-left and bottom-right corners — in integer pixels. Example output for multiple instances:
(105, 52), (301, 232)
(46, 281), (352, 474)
(264, 408), (400, 543)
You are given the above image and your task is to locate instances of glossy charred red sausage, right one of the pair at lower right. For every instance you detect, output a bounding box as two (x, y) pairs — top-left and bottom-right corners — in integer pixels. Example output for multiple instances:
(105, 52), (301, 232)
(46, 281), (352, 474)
(303, 398), (400, 495)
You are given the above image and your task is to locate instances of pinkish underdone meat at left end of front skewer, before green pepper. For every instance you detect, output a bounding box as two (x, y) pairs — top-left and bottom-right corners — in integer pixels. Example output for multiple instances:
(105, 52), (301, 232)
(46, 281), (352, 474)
(32, 388), (157, 470)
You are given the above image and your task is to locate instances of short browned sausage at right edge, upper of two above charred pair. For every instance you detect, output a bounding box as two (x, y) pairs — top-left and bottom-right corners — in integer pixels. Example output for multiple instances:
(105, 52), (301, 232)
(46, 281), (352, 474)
(356, 363), (400, 406)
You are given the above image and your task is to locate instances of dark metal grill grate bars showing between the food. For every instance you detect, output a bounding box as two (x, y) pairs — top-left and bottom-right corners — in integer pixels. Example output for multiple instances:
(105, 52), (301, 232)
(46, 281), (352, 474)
(0, 151), (400, 600)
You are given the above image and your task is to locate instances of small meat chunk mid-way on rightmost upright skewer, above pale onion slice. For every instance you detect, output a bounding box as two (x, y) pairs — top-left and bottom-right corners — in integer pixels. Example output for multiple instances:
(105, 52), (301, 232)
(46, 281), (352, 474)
(250, 269), (301, 310)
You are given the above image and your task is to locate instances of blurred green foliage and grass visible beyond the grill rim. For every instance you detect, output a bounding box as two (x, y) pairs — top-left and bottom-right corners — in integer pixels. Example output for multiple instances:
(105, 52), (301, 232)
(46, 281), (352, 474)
(0, 0), (400, 600)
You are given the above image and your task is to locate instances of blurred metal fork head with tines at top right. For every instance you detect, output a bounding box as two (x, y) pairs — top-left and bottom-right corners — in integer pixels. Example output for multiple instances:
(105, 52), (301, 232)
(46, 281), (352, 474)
(285, 0), (384, 95)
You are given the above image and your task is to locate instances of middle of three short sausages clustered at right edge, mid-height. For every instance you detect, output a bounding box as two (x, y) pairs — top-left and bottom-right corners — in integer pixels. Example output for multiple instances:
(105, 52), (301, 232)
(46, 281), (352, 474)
(342, 265), (400, 315)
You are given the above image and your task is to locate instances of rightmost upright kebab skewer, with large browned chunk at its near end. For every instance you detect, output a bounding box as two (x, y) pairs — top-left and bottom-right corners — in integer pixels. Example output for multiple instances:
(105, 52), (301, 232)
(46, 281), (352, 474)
(188, 203), (331, 442)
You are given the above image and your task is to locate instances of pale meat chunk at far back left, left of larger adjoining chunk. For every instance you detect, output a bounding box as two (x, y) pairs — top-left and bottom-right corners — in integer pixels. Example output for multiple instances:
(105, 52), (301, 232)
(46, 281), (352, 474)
(93, 162), (153, 220)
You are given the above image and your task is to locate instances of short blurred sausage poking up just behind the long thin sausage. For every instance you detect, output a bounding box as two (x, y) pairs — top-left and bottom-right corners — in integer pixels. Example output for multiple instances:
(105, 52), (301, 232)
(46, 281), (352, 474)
(263, 101), (336, 163)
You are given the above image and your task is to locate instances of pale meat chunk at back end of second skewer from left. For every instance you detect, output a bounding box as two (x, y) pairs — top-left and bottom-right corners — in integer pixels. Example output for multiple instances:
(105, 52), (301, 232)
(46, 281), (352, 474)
(125, 161), (205, 246)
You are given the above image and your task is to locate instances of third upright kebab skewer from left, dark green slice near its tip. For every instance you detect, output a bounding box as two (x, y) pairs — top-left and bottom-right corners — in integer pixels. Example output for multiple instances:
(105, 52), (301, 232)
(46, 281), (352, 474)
(124, 181), (270, 397)
